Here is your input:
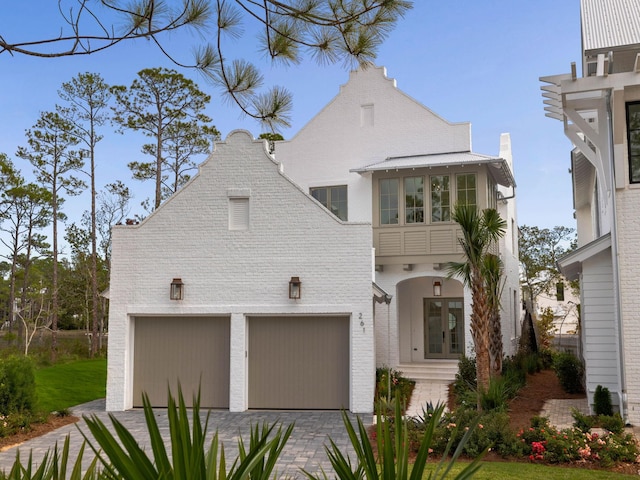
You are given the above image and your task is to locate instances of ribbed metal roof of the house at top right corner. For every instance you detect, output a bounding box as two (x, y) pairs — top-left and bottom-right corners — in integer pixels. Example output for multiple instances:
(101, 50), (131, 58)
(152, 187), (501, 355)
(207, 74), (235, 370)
(581, 0), (640, 52)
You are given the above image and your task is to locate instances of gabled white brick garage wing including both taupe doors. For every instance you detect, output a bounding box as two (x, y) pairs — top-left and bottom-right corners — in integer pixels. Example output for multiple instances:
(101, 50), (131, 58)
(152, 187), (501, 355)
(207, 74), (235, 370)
(107, 131), (375, 412)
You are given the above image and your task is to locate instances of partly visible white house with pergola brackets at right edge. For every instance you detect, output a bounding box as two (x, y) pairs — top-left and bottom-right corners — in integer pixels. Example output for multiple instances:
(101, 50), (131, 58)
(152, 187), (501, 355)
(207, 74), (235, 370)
(541, 0), (640, 425)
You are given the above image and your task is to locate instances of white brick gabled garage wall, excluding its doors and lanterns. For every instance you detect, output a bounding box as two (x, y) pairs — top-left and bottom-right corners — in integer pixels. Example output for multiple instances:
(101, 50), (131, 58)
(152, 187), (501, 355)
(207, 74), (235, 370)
(107, 131), (374, 412)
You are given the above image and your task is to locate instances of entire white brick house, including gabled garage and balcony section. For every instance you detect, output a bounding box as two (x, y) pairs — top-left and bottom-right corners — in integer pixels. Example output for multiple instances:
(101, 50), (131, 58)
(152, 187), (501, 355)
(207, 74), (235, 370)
(107, 67), (521, 412)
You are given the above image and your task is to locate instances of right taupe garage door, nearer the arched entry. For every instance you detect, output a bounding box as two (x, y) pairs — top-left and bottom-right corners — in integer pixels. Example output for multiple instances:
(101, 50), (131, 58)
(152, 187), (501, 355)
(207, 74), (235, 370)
(248, 317), (349, 409)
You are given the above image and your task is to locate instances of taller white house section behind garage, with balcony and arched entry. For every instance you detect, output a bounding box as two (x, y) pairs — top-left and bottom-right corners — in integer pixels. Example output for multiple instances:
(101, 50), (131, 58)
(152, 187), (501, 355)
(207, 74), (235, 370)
(275, 67), (521, 379)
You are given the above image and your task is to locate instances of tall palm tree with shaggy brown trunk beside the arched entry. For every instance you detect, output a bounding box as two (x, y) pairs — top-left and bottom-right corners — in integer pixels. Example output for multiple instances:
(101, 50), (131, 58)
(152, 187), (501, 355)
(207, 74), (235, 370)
(447, 205), (507, 402)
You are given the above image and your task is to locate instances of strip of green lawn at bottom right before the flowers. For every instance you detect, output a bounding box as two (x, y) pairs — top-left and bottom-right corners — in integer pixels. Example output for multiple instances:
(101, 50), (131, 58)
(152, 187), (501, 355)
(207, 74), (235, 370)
(423, 462), (638, 480)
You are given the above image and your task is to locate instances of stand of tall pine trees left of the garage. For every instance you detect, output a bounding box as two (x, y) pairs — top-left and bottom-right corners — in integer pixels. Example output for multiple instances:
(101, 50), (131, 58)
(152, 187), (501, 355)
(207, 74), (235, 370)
(0, 68), (219, 360)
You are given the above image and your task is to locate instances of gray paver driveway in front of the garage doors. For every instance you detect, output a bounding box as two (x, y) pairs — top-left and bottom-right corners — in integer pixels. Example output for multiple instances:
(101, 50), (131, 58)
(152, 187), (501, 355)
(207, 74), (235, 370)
(0, 400), (360, 478)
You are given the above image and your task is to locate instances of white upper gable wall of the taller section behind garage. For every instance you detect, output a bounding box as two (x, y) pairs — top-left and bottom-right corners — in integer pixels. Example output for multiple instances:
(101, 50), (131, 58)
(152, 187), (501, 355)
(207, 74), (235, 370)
(276, 67), (471, 222)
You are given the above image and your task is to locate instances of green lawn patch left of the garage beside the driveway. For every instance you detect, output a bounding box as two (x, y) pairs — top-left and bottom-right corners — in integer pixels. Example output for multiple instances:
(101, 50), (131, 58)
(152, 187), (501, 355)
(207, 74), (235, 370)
(36, 358), (107, 412)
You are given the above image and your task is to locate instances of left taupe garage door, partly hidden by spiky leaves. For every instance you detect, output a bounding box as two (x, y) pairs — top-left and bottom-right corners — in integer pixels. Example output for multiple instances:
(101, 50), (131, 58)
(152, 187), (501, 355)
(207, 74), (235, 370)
(133, 317), (229, 408)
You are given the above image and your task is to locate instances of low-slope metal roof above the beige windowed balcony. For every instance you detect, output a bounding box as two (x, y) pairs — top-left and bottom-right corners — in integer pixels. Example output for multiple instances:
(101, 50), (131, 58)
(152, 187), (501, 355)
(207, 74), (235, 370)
(351, 152), (516, 187)
